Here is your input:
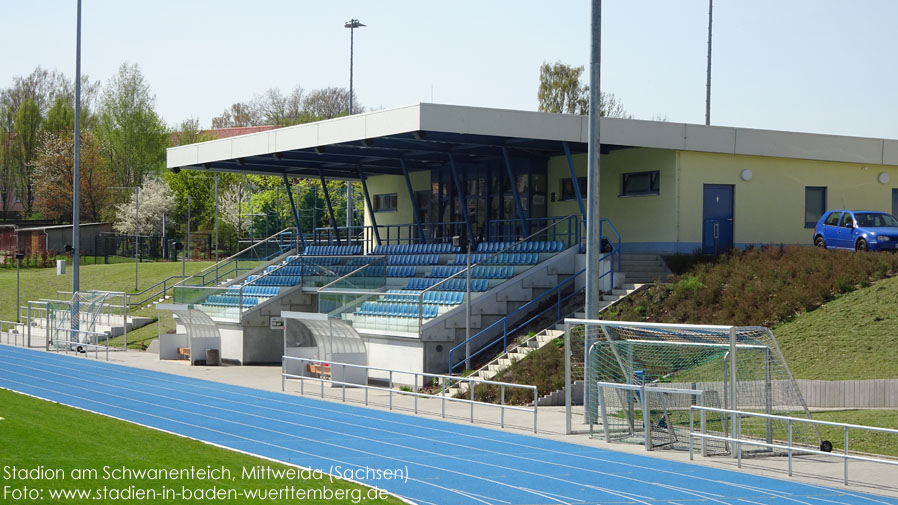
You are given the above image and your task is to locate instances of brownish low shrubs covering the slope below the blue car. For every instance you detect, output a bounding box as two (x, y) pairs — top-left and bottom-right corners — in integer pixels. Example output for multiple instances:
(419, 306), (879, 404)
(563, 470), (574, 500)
(604, 246), (898, 326)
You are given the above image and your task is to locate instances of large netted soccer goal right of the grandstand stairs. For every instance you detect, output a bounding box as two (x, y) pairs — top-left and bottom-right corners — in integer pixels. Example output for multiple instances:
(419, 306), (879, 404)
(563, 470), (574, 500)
(565, 319), (820, 454)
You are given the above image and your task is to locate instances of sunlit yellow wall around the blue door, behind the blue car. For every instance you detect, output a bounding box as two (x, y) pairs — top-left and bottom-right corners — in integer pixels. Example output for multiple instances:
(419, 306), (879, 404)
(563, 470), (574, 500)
(676, 151), (898, 245)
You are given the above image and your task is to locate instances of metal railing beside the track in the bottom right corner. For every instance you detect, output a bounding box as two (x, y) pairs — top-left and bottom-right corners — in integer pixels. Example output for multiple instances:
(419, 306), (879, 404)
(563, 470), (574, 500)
(689, 406), (898, 486)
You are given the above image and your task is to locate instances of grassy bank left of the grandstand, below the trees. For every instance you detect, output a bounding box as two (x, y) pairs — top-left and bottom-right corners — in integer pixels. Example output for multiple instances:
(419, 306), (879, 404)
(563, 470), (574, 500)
(0, 261), (213, 348)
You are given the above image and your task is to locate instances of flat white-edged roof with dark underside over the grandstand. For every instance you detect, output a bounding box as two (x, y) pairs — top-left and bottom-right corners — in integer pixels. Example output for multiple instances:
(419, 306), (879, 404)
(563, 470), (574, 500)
(167, 103), (898, 179)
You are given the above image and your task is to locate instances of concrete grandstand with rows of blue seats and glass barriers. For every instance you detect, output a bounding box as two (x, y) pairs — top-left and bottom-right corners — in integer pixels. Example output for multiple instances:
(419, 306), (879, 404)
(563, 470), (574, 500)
(164, 224), (582, 371)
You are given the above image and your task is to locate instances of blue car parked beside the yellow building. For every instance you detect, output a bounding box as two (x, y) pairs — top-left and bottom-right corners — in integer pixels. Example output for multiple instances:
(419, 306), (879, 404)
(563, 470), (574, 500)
(814, 210), (898, 251)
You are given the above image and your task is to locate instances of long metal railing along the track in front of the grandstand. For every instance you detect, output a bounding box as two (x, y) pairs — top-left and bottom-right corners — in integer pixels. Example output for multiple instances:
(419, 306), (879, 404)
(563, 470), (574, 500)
(281, 356), (539, 433)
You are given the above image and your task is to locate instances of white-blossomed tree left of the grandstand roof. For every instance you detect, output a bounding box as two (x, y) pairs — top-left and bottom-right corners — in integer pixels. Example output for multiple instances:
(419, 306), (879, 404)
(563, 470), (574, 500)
(113, 175), (175, 236)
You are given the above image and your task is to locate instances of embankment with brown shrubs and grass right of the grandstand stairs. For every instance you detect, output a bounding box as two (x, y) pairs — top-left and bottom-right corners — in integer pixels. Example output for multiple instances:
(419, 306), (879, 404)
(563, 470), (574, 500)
(482, 247), (898, 404)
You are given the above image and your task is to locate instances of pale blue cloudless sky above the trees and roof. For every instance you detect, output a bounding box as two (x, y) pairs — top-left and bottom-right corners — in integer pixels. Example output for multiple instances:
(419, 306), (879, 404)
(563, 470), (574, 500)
(0, 0), (898, 139)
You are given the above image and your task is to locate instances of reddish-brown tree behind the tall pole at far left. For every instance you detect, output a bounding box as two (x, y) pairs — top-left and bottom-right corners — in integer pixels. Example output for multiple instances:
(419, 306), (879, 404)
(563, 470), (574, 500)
(34, 132), (111, 223)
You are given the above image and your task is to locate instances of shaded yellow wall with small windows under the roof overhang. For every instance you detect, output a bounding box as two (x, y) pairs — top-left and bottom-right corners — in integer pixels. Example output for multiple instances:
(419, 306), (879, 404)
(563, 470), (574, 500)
(547, 148), (677, 243)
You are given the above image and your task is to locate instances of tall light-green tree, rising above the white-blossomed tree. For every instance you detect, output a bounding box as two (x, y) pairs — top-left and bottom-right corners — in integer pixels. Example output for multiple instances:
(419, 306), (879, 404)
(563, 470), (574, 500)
(97, 63), (168, 186)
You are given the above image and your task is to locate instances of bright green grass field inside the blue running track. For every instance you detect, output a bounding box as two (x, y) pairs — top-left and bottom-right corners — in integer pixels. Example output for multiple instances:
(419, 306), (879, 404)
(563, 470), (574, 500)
(0, 389), (401, 504)
